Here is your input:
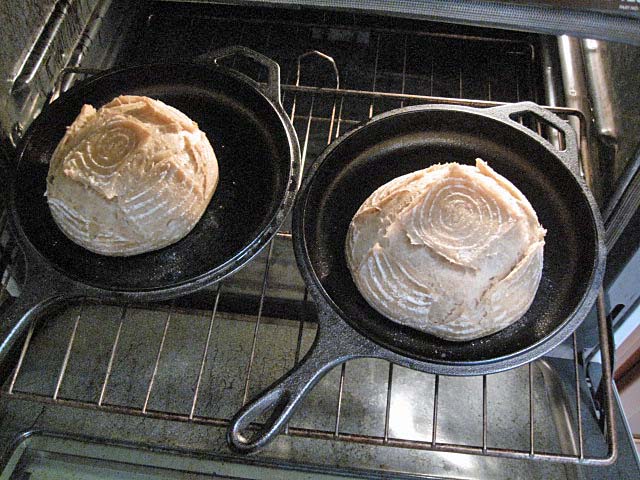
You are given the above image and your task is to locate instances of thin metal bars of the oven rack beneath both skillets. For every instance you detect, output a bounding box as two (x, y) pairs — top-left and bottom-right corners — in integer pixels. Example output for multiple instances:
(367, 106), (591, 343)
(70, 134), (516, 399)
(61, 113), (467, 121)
(1, 12), (617, 465)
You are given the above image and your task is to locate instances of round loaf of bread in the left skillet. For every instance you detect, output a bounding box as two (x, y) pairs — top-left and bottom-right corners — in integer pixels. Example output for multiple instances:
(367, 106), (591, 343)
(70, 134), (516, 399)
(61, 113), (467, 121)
(46, 96), (218, 256)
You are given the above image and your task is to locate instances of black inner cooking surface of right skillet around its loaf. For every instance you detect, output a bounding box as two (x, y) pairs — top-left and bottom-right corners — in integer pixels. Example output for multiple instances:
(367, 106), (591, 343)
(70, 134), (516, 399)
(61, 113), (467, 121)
(302, 110), (597, 363)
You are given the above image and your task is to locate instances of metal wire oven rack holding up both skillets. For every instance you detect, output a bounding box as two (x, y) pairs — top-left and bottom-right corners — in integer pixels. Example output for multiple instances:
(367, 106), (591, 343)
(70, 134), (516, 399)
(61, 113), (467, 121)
(0, 10), (617, 466)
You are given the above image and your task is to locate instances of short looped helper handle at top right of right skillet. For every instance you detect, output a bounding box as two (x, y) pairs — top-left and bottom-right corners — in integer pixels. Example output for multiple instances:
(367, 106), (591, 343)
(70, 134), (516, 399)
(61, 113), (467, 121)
(489, 102), (582, 177)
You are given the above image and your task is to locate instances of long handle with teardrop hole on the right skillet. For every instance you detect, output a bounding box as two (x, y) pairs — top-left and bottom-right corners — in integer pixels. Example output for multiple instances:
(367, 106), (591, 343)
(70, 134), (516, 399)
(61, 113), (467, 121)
(227, 317), (370, 453)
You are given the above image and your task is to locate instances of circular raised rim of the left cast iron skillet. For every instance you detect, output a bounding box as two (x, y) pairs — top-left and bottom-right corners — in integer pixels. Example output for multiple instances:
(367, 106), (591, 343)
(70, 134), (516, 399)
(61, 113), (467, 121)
(7, 62), (302, 300)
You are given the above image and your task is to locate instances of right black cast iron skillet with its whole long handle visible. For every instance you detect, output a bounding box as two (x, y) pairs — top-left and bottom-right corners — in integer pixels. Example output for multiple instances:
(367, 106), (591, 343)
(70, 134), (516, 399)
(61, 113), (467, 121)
(228, 102), (605, 452)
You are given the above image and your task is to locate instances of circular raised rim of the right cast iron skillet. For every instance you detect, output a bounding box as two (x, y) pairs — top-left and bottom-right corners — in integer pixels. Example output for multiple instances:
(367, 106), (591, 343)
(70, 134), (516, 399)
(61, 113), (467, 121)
(293, 102), (606, 375)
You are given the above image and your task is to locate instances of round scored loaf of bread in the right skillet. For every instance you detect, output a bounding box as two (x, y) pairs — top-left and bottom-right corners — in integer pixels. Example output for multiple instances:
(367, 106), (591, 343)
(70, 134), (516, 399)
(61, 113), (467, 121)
(346, 159), (546, 341)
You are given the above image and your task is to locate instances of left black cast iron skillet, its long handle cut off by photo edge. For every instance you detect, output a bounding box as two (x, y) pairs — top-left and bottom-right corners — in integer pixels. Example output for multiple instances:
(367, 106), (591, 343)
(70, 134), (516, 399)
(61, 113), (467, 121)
(0, 47), (301, 360)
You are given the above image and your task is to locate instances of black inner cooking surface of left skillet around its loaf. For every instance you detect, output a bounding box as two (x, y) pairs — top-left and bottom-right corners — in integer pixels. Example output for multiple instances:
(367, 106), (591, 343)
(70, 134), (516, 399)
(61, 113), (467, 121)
(16, 66), (291, 290)
